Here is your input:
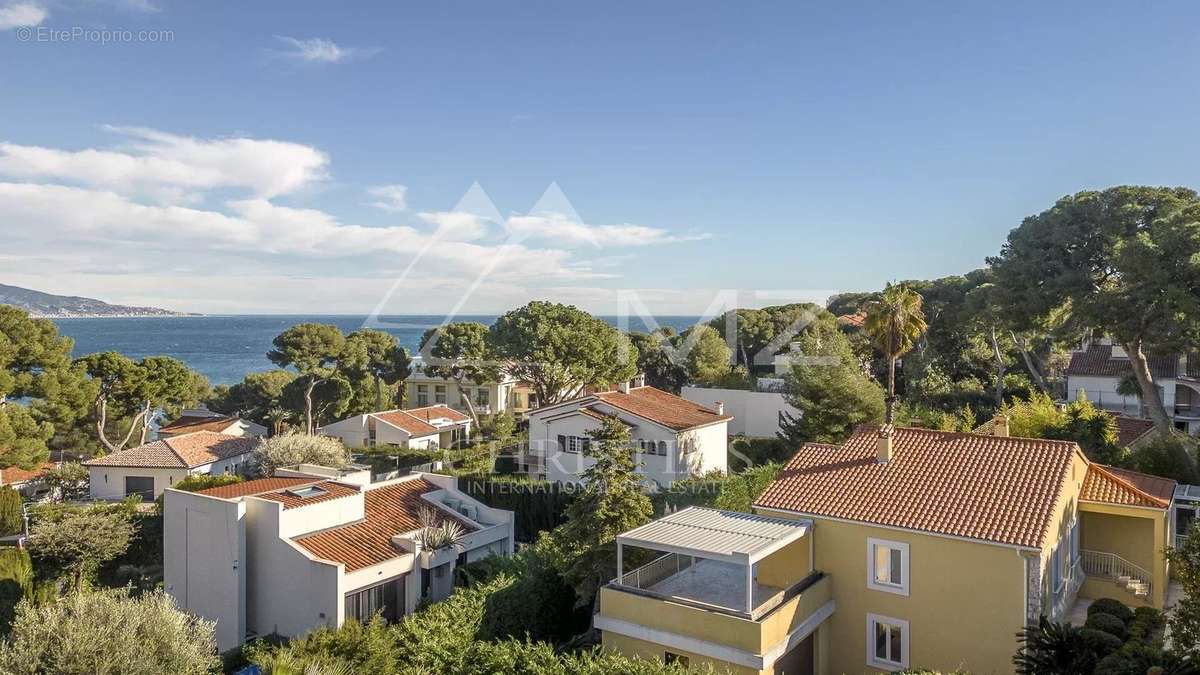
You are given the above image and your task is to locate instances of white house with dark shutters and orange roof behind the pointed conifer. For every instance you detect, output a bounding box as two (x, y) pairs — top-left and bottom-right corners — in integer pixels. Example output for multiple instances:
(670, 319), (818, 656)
(529, 384), (732, 488)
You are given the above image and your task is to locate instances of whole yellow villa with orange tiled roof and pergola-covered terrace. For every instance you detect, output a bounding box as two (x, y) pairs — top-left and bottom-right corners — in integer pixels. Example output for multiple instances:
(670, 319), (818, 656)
(595, 419), (1175, 675)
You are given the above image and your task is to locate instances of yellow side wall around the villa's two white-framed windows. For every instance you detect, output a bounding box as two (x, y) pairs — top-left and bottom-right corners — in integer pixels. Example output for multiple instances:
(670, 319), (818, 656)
(760, 509), (1025, 674)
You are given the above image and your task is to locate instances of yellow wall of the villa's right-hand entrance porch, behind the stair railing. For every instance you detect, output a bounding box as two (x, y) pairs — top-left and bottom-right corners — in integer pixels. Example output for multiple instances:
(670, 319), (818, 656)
(1080, 502), (1171, 609)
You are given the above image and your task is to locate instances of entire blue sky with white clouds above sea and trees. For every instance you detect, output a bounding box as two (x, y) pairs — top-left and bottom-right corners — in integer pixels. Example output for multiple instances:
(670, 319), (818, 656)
(0, 0), (1200, 315)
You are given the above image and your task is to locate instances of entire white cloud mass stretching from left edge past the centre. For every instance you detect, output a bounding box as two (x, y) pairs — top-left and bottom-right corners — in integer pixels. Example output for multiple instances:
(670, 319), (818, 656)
(0, 127), (710, 313)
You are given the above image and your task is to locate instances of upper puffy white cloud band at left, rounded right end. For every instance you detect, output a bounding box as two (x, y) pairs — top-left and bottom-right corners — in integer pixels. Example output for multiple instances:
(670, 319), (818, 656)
(0, 126), (329, 203)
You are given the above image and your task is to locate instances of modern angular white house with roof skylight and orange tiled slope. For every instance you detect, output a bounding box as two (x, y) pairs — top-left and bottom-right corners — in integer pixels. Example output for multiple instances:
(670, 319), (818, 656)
(163, 465), (514, 651)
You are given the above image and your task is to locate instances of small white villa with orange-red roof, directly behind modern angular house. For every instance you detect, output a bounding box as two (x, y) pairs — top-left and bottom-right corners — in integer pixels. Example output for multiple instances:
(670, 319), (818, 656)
(317, 405), (470, 450)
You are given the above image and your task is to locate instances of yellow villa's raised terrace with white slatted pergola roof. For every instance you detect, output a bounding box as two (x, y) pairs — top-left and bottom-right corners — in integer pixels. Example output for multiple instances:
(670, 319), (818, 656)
(595, 507), (834, 670)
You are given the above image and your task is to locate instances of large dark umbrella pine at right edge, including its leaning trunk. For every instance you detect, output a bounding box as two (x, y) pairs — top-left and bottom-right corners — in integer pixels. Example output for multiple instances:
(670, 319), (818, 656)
(988, 186), (1200, 434)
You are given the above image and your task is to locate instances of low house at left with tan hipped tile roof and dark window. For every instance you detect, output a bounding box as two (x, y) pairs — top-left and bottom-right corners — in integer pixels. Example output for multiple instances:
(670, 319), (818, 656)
(83, 431), (259, 501)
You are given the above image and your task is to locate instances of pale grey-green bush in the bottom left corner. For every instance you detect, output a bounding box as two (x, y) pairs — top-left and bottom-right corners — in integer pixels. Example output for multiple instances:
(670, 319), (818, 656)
(0, 590), (220, 675)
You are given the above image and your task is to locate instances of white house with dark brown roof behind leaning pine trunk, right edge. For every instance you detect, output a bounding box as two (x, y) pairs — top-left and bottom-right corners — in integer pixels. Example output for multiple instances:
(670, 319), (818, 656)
(1067, 338), (1200, 434)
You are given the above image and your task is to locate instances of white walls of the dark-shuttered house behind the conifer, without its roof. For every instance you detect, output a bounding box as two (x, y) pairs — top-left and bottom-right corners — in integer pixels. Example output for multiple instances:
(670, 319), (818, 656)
(529, 404), (728, 488)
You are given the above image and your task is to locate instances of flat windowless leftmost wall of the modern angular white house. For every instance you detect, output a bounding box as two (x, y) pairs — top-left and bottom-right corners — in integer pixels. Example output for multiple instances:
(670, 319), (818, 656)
(163, 490), (246, 652)
